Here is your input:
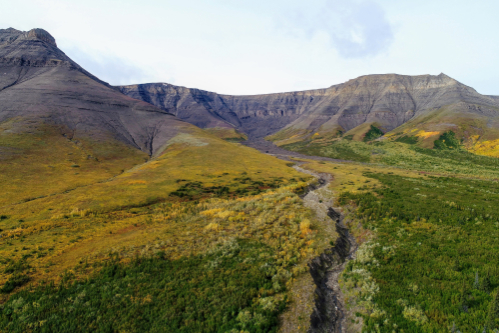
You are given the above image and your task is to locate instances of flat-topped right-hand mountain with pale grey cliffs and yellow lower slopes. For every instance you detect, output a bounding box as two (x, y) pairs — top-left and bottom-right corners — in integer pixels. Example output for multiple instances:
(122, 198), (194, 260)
(267, 74), (499, 152)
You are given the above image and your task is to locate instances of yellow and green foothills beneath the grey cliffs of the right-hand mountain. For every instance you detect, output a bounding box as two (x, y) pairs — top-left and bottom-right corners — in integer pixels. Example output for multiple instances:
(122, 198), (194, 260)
(280, 101), (499, 158)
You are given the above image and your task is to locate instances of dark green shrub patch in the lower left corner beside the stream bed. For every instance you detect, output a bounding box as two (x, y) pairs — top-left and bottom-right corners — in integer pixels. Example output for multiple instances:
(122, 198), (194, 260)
(0, 241), (285, 333)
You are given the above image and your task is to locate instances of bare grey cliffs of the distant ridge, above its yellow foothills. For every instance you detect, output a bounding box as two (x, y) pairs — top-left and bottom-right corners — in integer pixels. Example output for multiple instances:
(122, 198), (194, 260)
(120, 74), (499, 138)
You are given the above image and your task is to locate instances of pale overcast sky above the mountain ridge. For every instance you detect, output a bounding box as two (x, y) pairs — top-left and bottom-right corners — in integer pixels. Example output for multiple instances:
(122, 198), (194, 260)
(0, 0), (499, 95)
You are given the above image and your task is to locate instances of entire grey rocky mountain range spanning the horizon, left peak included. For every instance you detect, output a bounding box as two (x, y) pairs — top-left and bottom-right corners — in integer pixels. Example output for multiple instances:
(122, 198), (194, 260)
(0, 28), (499, 155)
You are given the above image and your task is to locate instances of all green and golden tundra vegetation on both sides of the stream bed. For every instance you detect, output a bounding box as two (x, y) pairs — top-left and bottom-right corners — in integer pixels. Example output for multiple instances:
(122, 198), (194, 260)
(0, 122), (499, 332)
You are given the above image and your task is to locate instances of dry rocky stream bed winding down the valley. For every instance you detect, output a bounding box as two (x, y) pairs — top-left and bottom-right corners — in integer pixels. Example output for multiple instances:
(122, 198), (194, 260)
(248, 136), (358, 333)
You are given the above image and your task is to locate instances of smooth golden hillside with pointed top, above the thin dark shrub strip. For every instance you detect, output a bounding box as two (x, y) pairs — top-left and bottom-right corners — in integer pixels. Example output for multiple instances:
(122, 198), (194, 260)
(0, 125), (303, 218)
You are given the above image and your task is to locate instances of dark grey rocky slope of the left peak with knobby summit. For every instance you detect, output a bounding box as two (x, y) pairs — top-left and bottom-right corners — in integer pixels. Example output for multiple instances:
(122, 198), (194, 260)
(0, 28), (191, 155)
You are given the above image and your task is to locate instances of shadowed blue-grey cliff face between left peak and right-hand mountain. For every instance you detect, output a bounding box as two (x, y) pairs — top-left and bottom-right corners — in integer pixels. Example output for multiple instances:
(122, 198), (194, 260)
(119, 83), (325, 137)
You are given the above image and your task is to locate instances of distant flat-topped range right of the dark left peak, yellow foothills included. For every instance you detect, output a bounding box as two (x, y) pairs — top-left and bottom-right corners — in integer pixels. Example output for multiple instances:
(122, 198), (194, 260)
(119, 74), (499, 152)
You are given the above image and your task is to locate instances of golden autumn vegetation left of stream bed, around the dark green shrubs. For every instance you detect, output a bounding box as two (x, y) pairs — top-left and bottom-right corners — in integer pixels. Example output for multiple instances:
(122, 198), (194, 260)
(0, 120), (356, 332)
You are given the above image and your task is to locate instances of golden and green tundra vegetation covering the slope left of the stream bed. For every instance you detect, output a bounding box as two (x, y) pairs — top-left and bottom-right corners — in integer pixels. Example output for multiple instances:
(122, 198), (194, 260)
(0, 120), (348, 332)
